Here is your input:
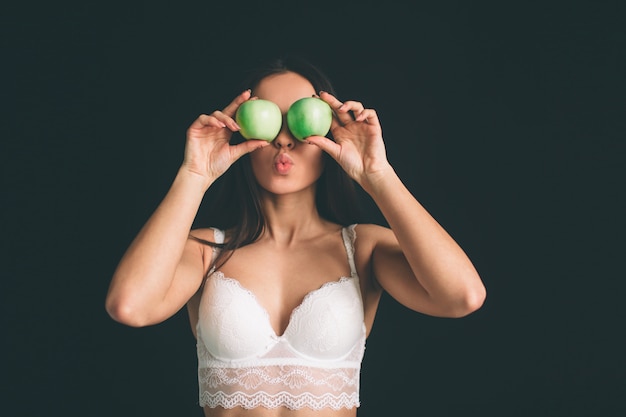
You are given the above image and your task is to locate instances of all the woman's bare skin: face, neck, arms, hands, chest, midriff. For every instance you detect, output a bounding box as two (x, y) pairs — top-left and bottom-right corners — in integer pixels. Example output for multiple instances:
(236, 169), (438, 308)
(106, 72), (486, 417)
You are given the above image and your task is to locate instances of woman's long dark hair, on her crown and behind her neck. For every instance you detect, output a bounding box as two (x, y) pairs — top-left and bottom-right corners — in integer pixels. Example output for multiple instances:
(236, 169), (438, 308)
(190, 55), (362, 268)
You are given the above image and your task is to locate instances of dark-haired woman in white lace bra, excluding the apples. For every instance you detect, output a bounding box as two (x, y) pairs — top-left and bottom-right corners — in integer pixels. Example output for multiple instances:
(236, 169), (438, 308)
(106, 56), (485, 417)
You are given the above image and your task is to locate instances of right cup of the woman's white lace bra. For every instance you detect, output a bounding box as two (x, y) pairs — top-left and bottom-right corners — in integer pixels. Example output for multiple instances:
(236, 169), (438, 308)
(283, 278), (364, 360)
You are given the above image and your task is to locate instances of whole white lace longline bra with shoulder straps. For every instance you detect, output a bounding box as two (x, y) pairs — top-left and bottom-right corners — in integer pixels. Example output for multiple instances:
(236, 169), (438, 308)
(197, 225), (365, 410)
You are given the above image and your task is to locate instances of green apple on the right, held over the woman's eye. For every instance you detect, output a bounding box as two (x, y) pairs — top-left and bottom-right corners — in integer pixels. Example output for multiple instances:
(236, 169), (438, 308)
(287, 97), (333, 141)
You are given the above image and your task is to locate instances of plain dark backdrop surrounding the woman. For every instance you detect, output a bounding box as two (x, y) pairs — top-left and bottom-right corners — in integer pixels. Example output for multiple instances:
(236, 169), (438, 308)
(0, 1), (626, 417)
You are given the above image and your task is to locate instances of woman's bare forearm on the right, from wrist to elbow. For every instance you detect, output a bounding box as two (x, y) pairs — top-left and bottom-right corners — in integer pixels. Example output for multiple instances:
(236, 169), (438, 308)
(367, 167), (484, 303)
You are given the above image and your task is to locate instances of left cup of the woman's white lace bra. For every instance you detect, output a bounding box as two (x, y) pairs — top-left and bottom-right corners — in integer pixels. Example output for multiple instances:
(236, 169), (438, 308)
(198, 276), (276, 361)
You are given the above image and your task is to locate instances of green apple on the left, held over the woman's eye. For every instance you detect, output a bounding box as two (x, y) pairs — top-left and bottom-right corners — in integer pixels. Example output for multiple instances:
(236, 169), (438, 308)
(235, 99), (283, 142)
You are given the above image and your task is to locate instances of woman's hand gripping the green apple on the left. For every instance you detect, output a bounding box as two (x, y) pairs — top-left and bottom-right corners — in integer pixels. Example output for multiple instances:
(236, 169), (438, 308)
(182, 90), (269, 185)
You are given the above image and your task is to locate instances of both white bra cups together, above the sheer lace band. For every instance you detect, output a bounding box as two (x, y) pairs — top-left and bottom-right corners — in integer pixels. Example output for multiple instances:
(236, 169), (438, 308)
(197, 271), (365, 362)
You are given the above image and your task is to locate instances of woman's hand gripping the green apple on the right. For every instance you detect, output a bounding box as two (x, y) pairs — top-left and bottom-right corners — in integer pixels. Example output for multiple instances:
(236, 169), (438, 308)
(307, 92), (391, 190)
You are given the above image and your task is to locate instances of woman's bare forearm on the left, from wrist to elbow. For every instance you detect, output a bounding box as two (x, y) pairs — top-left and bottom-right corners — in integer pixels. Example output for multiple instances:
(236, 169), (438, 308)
(107, 170), (208, 311)
